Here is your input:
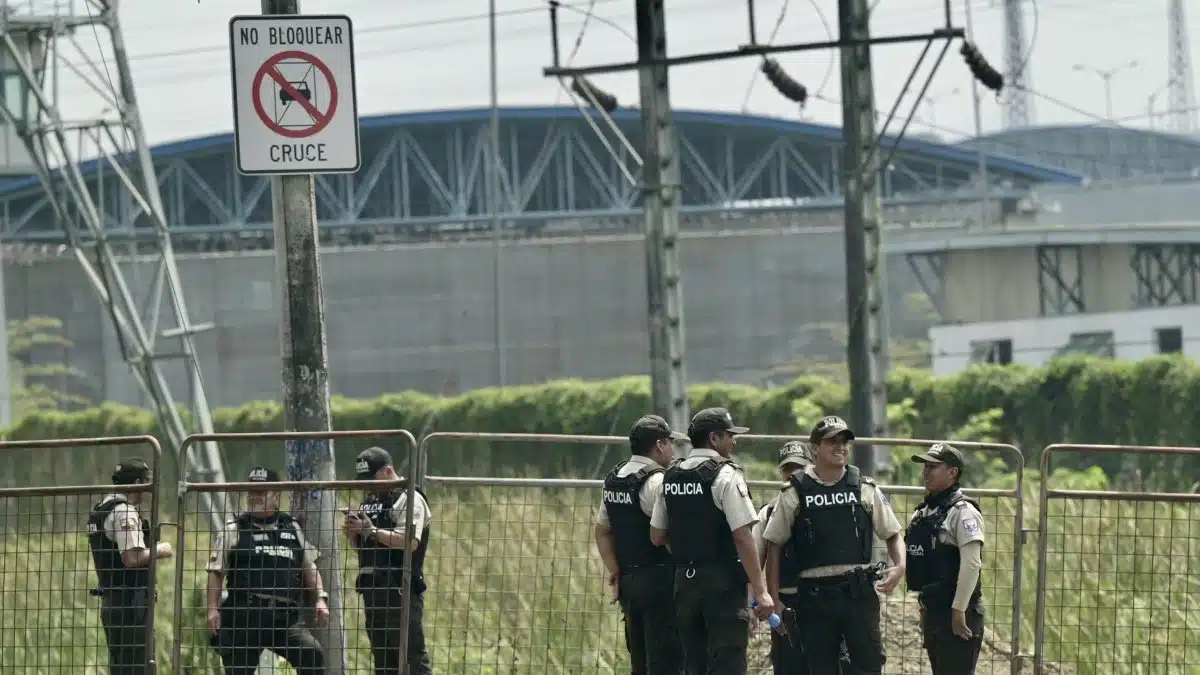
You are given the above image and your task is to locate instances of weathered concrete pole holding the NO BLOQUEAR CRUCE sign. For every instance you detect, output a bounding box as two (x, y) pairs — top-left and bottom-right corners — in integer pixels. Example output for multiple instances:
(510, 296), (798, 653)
(262, 0), (346, 675)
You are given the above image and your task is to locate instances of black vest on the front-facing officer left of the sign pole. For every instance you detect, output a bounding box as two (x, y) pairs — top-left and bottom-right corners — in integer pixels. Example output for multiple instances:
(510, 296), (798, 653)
(226, 513), (304, 605)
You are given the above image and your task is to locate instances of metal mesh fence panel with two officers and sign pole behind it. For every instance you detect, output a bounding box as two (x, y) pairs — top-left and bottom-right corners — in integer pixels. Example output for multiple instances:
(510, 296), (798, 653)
(171, 430), (420, 675)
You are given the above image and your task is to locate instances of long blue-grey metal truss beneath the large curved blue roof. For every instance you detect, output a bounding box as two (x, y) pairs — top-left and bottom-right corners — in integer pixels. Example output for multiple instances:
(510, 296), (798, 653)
(0, 114), (1046, 240)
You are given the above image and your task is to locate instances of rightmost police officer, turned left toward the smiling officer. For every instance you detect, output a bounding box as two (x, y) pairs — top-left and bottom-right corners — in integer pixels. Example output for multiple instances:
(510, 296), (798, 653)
(905, 443), (984, 675)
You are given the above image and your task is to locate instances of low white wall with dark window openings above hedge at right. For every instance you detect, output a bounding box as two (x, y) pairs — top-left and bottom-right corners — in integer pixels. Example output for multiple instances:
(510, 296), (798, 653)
(929, 306), (1200, 375)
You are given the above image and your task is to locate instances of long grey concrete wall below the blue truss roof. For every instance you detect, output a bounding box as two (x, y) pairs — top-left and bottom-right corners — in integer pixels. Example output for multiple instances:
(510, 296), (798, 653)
(5, 223), (919, 407)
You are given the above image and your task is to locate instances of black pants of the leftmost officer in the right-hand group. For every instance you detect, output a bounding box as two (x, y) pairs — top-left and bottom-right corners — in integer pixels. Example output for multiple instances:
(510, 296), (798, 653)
(619, 567), (683, 675)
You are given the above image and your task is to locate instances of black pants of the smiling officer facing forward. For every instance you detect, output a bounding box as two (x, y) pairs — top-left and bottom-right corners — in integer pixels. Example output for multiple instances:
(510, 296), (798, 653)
(797, 572), (887, 675)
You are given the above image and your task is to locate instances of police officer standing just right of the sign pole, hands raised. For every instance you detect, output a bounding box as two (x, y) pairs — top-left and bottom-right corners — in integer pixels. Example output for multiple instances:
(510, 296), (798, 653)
(343, 447), (433, 675)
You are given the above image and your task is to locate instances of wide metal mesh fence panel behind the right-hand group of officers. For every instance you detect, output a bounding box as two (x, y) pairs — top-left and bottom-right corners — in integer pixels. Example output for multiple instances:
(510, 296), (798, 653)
(417, 435), (1021, 675)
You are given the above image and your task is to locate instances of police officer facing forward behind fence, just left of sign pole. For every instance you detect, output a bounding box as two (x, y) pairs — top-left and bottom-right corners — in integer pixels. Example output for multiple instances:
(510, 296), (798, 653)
(206, 466), (329, 675)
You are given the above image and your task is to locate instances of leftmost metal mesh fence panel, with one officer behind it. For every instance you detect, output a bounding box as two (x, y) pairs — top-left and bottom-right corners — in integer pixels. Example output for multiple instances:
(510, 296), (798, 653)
(0, 437), (162, 675)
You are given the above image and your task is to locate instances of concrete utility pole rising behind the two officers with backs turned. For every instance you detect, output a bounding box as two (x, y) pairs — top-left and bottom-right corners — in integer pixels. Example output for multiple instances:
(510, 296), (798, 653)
(636, 0), (691, 430)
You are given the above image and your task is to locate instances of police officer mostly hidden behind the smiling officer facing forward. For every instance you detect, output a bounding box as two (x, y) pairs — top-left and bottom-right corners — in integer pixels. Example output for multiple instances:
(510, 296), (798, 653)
(752, 441), (812, 675)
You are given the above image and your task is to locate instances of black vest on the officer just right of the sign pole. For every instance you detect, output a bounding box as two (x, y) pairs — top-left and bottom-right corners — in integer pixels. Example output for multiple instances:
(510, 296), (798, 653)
(358, 486), (430, 593)
